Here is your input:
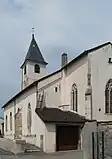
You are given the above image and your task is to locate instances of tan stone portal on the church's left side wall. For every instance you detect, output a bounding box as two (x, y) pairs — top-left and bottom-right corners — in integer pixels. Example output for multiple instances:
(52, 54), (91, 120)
(15, 109), (22, 139)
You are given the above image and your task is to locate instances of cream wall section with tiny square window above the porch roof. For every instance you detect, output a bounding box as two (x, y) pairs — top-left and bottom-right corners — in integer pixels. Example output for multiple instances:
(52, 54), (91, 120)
(38, 72), (61, 107)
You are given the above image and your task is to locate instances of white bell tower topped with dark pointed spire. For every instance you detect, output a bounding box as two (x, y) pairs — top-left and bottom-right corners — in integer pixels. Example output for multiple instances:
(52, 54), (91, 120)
(21, 28), (48, 89)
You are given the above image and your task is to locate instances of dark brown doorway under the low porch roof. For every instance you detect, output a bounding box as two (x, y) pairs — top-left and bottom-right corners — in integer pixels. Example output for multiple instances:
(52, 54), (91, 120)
(56, 126), (79, 151)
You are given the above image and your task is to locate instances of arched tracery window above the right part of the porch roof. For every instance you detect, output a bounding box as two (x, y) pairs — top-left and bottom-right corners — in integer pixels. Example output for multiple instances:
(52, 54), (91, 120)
(71, 84), (78, 112)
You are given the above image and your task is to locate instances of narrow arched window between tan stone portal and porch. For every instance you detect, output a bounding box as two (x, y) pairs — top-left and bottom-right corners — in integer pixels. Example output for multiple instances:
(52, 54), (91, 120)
(27, 103), (32, 133)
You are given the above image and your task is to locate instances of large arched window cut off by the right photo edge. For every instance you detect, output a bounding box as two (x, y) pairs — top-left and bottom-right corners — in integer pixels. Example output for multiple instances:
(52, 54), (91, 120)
(105, 79), (112, 113)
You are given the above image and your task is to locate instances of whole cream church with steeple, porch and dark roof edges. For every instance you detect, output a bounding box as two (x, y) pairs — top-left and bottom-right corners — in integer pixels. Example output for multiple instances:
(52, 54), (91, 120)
(2, 34), (112, 152)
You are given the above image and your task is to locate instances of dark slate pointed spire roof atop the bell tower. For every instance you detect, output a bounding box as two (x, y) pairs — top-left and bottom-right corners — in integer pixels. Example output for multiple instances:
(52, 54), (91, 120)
(21, 34), (48, 68)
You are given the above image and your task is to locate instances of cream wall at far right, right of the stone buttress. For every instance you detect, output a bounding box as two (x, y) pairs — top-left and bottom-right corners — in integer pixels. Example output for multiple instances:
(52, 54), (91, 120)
(89, 44), (112, 121)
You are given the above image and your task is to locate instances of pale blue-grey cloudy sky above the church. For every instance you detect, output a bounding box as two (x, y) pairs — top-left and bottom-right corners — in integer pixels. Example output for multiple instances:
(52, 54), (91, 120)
(0, 0), (112, 114)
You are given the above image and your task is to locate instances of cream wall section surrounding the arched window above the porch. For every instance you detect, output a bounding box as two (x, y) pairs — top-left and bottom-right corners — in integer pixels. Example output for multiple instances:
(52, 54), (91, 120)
(61, 56), (88, 115)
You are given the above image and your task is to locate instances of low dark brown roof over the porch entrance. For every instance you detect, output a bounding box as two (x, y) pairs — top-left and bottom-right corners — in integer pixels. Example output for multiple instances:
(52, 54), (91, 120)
(35, 107), (86, 123)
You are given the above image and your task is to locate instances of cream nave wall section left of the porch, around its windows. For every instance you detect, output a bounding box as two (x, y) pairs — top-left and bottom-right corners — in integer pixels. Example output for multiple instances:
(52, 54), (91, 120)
(4, 87), (36, 142)
